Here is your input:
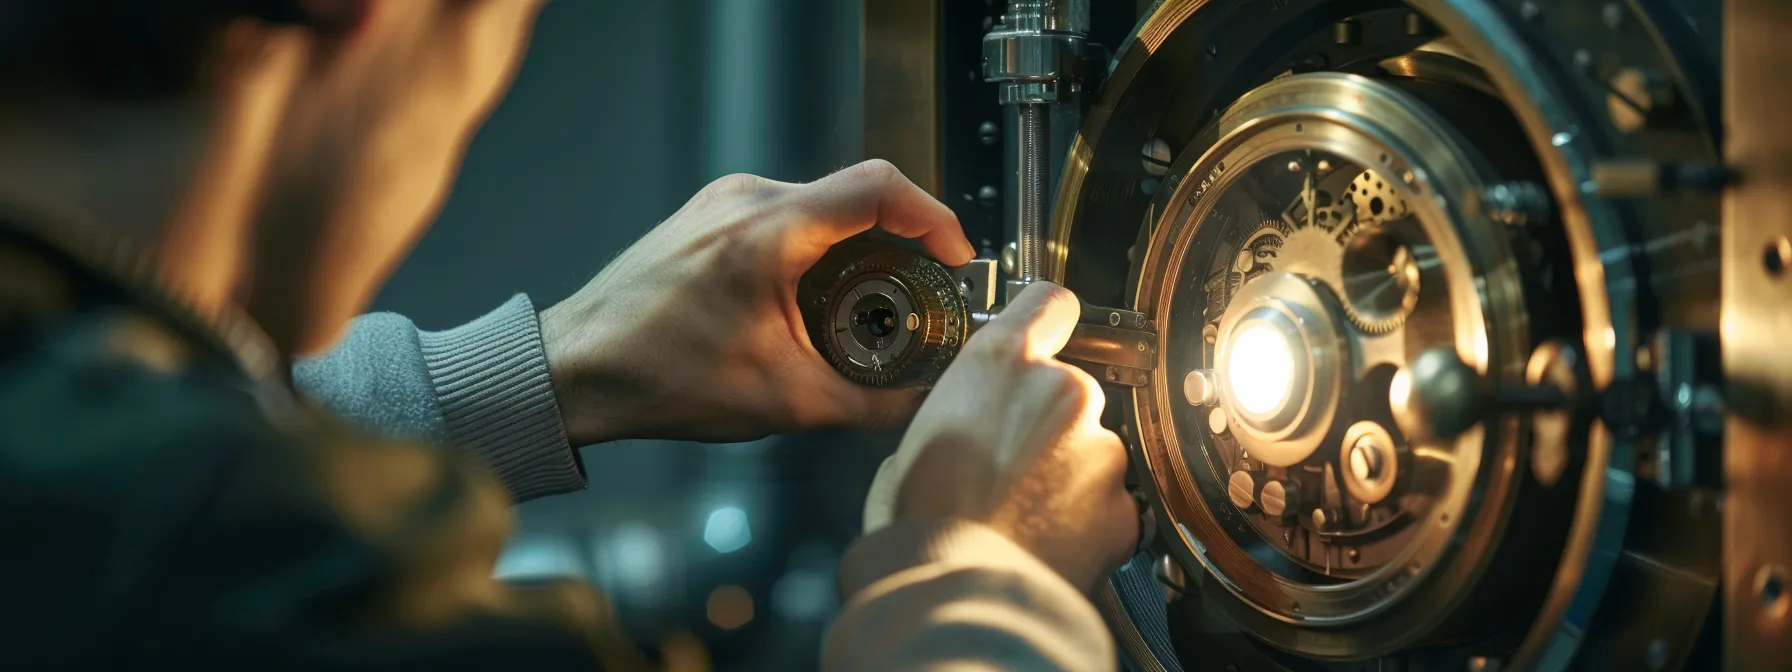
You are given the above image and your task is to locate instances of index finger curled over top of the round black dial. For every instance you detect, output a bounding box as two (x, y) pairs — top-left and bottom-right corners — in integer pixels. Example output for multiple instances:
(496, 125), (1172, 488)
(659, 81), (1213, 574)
(803, 159), (977, 265)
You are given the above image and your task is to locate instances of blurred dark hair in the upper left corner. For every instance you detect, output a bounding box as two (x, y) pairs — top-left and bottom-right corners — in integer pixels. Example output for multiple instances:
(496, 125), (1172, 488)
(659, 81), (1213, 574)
(0, 0), (303, 100)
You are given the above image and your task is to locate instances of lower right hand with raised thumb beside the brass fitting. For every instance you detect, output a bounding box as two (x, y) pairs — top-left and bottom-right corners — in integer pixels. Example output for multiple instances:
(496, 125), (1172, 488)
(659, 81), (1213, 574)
(866, 283), (1138, 591)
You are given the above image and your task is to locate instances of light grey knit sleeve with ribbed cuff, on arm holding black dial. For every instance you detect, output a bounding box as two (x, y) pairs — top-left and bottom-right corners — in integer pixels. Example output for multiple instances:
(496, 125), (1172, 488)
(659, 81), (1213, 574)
(292, 294), (584, 502)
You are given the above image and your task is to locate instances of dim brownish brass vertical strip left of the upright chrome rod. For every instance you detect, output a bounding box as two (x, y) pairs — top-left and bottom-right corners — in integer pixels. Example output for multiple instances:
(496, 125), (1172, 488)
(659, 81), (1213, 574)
(860, 0), (946, 199)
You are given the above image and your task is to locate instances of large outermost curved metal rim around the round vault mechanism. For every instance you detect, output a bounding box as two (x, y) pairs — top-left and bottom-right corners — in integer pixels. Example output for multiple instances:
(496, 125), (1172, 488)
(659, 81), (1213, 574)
(1048, 0), (1638, 667)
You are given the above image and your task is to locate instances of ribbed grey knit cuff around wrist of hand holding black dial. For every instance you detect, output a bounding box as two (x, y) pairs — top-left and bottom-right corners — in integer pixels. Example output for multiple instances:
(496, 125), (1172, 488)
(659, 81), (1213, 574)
(418, 294), (584, 502)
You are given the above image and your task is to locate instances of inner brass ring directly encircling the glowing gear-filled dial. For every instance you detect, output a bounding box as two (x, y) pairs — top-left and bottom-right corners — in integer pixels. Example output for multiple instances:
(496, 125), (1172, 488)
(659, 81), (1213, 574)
(1134, 73), (1529, 658)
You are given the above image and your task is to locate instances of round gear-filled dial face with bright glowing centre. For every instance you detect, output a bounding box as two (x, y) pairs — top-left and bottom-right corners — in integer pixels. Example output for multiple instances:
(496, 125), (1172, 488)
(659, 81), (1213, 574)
(1165, 151), (1430, 584)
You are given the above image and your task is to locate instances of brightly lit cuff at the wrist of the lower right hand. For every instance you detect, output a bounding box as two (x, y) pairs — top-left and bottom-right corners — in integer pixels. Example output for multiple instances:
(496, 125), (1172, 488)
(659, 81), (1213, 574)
(839, 520), (1077, 597)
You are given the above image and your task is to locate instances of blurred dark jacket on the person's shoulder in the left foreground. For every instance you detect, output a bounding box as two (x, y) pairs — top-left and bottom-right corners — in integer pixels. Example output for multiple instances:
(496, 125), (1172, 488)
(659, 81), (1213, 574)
(0, 222), (642, 670)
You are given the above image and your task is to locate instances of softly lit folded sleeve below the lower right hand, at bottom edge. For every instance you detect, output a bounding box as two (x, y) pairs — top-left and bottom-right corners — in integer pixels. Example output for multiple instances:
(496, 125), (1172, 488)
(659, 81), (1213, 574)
(823, 523), (1116, 670)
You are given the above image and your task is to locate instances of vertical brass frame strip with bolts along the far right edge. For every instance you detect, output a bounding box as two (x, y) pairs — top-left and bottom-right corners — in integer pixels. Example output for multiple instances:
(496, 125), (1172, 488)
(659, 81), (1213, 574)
(1722, 0), (1792, 670)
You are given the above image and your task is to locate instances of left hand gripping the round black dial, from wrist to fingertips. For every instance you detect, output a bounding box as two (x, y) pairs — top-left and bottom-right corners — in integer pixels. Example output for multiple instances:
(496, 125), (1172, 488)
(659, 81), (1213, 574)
(541, 161), (975, 444)
